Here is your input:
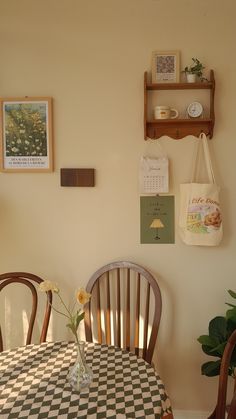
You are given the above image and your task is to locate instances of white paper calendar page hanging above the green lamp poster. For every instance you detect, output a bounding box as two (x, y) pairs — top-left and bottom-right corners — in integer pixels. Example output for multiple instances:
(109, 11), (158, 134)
(140, 157), (169, 194)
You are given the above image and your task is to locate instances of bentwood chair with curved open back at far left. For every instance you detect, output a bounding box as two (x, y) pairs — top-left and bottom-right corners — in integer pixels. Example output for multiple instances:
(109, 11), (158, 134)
(0, 272), (52, 352)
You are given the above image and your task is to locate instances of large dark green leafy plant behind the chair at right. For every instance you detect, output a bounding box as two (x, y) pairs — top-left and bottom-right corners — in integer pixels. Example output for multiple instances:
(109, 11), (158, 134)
(198, 290), (236, 385)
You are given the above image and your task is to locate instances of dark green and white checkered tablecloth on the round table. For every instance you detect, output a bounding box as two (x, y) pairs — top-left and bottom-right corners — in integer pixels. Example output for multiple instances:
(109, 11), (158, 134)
(0, 342), (171, 419)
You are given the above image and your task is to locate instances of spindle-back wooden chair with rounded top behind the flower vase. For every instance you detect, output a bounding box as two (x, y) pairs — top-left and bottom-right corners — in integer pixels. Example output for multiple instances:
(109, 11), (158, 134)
(84, 261), (162, 363)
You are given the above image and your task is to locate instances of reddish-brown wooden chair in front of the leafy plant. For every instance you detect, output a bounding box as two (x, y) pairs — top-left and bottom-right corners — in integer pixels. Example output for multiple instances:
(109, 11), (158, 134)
(208, 330), (236, 419)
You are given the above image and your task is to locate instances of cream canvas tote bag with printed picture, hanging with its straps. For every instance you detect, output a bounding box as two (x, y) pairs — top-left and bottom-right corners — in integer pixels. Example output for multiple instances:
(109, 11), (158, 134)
(179, 134), (223, 246)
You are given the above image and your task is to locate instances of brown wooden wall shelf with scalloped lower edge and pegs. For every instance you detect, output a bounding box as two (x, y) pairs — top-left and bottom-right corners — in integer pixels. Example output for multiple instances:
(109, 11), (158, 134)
(144, 70), (215, 140)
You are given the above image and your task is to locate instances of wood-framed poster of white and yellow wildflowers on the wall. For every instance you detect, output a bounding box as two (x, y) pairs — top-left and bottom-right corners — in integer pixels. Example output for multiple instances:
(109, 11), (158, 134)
(0, 97), (53, 172)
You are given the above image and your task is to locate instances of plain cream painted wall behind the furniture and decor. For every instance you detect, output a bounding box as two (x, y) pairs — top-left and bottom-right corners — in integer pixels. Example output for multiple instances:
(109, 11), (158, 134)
(0, 0), (236, 411)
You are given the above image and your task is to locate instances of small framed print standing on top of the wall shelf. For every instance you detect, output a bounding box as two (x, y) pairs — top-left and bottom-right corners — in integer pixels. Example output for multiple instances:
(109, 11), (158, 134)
(152, 51), (180, 83)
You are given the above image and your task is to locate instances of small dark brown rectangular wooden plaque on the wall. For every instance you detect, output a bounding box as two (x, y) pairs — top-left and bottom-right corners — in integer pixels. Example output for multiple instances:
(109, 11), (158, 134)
(61, 169), (94, 186)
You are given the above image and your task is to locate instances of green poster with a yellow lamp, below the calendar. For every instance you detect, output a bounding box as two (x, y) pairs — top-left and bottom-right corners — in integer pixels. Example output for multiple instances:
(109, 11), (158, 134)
(140, 195), (175, 244)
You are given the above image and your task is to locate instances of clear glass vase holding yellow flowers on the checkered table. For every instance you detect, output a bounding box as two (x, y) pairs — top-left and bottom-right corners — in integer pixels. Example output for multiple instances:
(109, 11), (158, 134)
(68, 341), (93, 392)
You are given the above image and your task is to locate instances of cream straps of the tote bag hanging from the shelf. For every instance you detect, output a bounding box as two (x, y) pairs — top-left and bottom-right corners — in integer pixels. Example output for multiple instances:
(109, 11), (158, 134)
(191, 133), (216, 183)
